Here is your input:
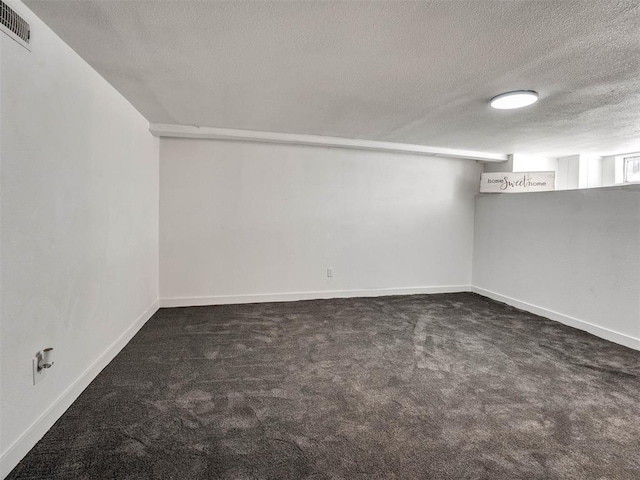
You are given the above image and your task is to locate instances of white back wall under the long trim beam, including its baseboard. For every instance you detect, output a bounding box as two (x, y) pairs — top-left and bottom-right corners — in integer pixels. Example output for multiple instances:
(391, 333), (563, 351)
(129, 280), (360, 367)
(160, 139), (481, 306)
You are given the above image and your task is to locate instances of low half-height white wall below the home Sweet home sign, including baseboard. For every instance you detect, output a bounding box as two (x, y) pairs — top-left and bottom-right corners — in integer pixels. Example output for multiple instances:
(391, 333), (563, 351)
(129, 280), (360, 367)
(473, 185), (640, 349)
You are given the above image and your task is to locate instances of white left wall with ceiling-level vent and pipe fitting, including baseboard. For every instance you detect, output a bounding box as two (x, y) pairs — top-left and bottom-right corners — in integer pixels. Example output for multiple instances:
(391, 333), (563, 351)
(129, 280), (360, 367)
(0, 1), (159, 476)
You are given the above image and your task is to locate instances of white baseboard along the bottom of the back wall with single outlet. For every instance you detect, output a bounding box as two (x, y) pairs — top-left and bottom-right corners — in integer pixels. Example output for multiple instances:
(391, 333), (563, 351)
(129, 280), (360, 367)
(160, 285), (471, 307)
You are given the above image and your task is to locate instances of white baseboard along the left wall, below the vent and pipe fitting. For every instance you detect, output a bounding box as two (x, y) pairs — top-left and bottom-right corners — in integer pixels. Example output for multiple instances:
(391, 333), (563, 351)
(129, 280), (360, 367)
(0, 300), (159, 478)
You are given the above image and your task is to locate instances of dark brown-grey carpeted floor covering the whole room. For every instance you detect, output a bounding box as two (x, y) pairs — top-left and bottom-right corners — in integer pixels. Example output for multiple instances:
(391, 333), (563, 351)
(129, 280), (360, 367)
(8, 294), (640, 480)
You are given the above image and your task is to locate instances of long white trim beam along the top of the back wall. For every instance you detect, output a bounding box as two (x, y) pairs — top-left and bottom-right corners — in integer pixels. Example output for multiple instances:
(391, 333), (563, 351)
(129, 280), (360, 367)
(149, 123), (508, 162)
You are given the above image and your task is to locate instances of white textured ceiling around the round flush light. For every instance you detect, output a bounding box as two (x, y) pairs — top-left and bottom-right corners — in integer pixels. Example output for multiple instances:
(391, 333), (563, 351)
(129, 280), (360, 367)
(25, 0), (640, 156)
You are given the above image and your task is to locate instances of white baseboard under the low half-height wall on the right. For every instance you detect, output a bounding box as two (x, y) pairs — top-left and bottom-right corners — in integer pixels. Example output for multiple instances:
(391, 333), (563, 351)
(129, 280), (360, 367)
(471, 286), (640, 350)
